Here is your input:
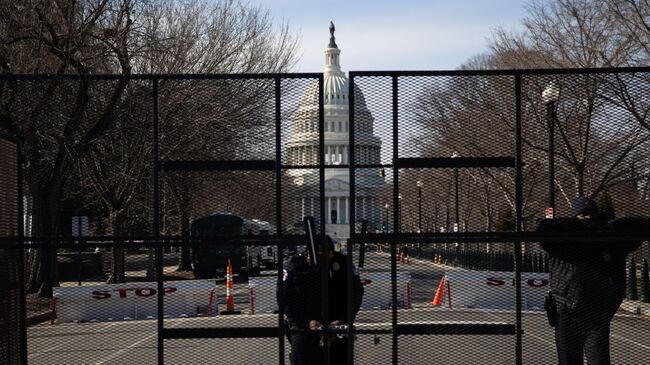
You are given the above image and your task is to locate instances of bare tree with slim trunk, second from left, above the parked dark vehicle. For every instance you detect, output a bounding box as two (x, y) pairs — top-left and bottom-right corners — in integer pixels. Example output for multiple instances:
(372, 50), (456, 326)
(144, 1), (297, 270)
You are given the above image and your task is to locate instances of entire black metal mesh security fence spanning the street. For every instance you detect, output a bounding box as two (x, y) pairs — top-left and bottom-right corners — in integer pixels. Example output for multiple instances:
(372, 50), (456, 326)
(0, 69), (650, 364)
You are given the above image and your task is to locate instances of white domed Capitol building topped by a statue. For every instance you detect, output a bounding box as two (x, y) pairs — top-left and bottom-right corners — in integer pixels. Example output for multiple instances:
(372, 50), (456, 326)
(285, 24), (384, 240)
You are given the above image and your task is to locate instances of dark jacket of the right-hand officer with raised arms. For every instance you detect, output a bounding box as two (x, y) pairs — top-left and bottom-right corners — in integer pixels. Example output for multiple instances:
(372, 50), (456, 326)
(537, 218), (650, 320)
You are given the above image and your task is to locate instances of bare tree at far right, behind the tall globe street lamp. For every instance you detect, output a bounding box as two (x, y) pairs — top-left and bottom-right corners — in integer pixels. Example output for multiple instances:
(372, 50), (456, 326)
(491, 0), (650, 212)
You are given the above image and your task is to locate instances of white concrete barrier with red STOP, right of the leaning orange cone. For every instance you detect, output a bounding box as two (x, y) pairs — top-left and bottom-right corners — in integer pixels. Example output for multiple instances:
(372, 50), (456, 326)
(443, 270), (549, 311)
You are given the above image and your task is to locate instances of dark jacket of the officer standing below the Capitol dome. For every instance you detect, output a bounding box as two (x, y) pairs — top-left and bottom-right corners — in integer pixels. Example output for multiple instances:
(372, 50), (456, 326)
(278, 253), (363, 329)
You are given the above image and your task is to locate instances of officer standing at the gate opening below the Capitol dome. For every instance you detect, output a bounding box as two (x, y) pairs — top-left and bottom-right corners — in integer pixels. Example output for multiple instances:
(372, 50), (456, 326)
(278, 236), (363, 365)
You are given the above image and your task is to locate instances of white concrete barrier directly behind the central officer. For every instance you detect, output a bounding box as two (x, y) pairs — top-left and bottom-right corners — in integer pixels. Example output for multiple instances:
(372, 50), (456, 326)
(248, 272), (411, 314)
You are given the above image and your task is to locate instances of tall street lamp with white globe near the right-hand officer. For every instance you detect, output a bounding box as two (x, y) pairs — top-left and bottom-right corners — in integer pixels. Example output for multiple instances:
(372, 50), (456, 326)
(542, 81), (560, 218)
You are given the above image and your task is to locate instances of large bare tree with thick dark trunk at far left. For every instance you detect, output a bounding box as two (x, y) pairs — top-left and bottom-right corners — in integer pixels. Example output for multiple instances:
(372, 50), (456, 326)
(0, 0), (136, 296)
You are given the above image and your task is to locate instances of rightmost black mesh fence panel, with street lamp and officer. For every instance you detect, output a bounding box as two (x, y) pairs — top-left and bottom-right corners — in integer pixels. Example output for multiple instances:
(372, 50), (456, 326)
(521, 72), (650, 364)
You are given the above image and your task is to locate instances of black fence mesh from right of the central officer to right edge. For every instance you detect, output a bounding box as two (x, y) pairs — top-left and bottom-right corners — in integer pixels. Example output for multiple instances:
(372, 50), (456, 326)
(351, 72), (650, 364)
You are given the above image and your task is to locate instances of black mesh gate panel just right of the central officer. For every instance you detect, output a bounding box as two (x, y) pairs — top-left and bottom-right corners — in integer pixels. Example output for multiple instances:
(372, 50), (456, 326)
(350, 72), (521, 364)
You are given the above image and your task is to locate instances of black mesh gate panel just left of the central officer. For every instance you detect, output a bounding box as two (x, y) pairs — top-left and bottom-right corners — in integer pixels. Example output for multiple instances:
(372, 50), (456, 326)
(154, 74), (324, 364)
